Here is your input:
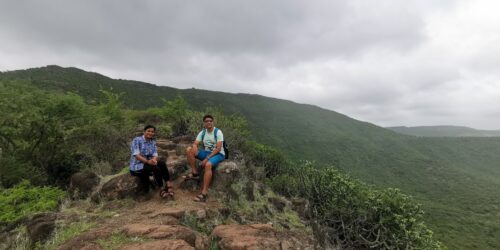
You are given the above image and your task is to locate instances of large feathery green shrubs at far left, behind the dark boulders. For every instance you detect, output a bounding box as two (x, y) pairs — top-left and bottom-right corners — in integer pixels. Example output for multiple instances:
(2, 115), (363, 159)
(0, 82), (131, 187)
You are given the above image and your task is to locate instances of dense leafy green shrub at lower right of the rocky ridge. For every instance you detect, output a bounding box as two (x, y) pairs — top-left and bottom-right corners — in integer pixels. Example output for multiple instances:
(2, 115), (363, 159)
(270, 162), (441, 249)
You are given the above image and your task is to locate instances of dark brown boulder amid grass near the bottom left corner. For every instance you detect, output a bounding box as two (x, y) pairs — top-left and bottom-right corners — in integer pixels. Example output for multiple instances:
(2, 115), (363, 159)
(26, 213), (57, 242)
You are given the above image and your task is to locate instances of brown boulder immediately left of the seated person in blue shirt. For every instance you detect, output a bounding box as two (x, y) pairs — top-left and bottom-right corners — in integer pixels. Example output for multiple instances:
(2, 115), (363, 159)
(92, 173), (142, 202)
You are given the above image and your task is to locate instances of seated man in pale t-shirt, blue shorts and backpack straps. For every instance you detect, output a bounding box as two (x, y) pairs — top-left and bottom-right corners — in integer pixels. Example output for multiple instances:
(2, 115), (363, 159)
(184, 115), (225, 202)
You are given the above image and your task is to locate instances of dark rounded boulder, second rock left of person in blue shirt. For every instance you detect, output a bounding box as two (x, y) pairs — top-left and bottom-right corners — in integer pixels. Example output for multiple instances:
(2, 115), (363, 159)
(68, 171), (100, 199)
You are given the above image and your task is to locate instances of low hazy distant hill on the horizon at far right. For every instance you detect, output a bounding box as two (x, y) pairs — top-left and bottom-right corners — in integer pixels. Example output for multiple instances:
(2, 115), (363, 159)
(387, 126), (500, 137)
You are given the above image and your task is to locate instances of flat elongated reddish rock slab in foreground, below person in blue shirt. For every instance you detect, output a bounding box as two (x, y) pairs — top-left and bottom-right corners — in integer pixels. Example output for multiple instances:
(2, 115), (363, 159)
(123, 224), (196, 247)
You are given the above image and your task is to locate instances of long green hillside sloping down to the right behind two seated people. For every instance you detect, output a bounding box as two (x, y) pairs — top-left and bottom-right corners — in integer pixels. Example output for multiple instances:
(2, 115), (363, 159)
(0, 66), (500, 249)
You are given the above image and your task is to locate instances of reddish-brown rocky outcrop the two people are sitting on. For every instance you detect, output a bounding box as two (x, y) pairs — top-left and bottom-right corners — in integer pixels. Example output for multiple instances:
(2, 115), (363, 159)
(45, 138), (314, 250)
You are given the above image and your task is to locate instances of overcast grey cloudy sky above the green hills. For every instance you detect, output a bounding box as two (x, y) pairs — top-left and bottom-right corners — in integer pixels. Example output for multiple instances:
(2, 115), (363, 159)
(0, 0), (500, 129)
